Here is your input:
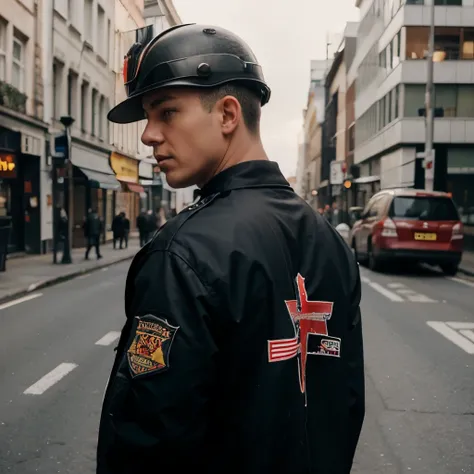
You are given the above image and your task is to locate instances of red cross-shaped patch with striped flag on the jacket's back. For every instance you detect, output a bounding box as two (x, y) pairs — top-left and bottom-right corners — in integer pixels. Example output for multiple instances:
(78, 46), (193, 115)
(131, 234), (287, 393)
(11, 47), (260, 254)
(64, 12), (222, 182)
(268, 273), (341, 393)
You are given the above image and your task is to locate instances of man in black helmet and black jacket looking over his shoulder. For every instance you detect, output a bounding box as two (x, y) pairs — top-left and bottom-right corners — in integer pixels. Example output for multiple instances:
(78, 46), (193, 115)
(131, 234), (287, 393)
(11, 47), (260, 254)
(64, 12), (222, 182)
(97, 25), (364, 474)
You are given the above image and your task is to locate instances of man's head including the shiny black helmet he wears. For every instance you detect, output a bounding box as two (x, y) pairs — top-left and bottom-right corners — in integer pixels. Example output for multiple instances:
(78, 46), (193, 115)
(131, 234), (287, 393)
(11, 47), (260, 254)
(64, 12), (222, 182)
(108, 24), (270, 187)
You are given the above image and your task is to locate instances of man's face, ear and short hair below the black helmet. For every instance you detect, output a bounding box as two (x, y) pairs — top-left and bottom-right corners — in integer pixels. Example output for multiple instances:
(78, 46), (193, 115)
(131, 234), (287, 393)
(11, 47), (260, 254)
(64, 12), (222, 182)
(142, 83), (261, 188)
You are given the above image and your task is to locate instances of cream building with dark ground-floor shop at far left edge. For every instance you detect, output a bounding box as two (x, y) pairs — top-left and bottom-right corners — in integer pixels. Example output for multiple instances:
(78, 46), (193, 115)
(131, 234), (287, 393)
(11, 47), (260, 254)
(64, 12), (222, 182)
(0, 0), (48, 253)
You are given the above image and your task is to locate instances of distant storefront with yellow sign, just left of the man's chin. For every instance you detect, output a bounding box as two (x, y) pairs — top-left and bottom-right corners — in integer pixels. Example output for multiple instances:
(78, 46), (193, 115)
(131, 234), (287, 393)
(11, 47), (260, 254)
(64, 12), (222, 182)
(110, 152), (145, 229)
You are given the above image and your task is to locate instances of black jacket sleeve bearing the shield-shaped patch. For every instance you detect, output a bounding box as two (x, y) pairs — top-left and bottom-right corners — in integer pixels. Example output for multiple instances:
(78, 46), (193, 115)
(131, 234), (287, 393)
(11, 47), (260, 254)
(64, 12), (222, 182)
(99, 251), (217, 473)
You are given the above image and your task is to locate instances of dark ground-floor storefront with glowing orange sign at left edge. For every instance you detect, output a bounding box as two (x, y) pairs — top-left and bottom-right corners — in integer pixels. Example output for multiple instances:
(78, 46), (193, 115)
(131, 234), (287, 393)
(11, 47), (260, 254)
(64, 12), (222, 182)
(0, 124), (44, 253)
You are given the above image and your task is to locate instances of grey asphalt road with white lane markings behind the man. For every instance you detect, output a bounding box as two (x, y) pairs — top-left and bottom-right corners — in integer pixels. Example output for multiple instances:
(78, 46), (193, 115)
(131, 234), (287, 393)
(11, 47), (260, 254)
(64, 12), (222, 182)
(0, 264), (474, 474)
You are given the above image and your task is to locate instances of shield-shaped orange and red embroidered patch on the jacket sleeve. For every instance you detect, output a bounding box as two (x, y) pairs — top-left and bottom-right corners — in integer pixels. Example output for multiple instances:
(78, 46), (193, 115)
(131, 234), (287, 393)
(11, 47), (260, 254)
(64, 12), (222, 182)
(127, 314), (179, 377)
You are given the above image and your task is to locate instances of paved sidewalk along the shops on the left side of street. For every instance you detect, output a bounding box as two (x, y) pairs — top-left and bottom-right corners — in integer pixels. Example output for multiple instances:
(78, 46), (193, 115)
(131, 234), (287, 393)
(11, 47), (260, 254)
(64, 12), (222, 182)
(0, 237), (140, 302)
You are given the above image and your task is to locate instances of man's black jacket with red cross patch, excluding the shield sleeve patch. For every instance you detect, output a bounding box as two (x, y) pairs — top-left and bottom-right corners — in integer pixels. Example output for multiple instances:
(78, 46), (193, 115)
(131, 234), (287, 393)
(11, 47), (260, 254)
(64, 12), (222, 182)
(98, 162), (364, 474)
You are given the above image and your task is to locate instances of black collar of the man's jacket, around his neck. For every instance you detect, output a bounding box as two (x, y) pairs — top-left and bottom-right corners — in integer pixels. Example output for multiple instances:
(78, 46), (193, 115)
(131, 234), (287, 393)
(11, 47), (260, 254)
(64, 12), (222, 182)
(199, 160), (291, 197)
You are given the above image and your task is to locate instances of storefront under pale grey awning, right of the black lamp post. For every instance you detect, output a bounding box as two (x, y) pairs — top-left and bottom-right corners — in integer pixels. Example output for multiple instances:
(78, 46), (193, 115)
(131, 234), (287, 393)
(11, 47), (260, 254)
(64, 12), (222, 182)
(71, 142), (120, 247)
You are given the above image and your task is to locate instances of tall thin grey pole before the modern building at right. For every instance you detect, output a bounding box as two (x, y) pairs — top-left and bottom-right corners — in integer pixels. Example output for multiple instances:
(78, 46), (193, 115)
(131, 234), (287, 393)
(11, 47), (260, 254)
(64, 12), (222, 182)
(424, 0), (435, 191)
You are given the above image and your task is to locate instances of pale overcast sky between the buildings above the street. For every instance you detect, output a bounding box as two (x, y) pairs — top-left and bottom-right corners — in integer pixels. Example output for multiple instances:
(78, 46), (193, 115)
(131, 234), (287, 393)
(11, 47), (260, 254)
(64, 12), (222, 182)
(173, 0), (359, 177)
